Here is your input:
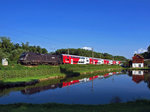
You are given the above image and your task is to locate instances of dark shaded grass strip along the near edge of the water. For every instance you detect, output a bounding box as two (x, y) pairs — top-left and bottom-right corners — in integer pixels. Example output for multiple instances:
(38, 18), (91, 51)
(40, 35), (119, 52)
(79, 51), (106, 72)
(0, 100), (150, 112)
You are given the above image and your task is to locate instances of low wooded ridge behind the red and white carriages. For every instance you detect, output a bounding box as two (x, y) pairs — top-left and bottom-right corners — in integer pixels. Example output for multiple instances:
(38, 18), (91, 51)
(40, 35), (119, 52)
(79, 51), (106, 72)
(54, 48), (127, 61)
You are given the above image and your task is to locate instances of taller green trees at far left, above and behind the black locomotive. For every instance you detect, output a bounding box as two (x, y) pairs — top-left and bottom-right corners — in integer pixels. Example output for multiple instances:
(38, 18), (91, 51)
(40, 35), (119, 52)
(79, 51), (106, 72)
(0, 37), (48, 61)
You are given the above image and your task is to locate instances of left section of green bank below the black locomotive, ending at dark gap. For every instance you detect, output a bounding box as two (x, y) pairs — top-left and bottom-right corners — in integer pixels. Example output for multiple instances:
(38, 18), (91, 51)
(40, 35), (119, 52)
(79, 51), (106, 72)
(0, 65), (65, 83)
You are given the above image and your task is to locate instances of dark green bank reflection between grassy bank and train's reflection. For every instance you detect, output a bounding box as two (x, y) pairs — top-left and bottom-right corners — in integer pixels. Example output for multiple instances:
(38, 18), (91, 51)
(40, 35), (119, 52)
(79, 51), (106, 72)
(0, 70), (122, 96)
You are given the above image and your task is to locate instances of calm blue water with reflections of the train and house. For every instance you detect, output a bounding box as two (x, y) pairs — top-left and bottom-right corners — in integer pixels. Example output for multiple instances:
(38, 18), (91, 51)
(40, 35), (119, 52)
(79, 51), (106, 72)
(0, 71), (150, 104)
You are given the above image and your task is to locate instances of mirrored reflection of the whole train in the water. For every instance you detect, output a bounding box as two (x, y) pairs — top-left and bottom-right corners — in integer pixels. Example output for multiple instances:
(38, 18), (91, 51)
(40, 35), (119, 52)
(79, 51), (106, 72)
(21, 72), (121, 95)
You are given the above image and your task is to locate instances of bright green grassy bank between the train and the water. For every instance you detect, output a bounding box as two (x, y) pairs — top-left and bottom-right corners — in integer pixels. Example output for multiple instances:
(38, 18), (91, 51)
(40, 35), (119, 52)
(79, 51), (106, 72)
(0, 64), (122, 83)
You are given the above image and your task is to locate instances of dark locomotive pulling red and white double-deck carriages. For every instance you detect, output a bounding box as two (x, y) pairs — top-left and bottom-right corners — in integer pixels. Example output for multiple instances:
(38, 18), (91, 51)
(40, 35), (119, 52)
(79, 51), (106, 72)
(18, 52), (121, 65)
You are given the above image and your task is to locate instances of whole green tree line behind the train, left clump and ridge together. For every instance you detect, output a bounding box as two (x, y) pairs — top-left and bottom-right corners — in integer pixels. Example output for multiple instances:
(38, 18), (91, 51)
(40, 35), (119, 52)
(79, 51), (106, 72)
(0, 37), (127, 61)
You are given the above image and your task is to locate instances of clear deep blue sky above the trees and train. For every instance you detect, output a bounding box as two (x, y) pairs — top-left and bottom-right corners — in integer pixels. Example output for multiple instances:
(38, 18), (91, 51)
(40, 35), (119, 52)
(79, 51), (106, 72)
(0, 0), (150, 58)
